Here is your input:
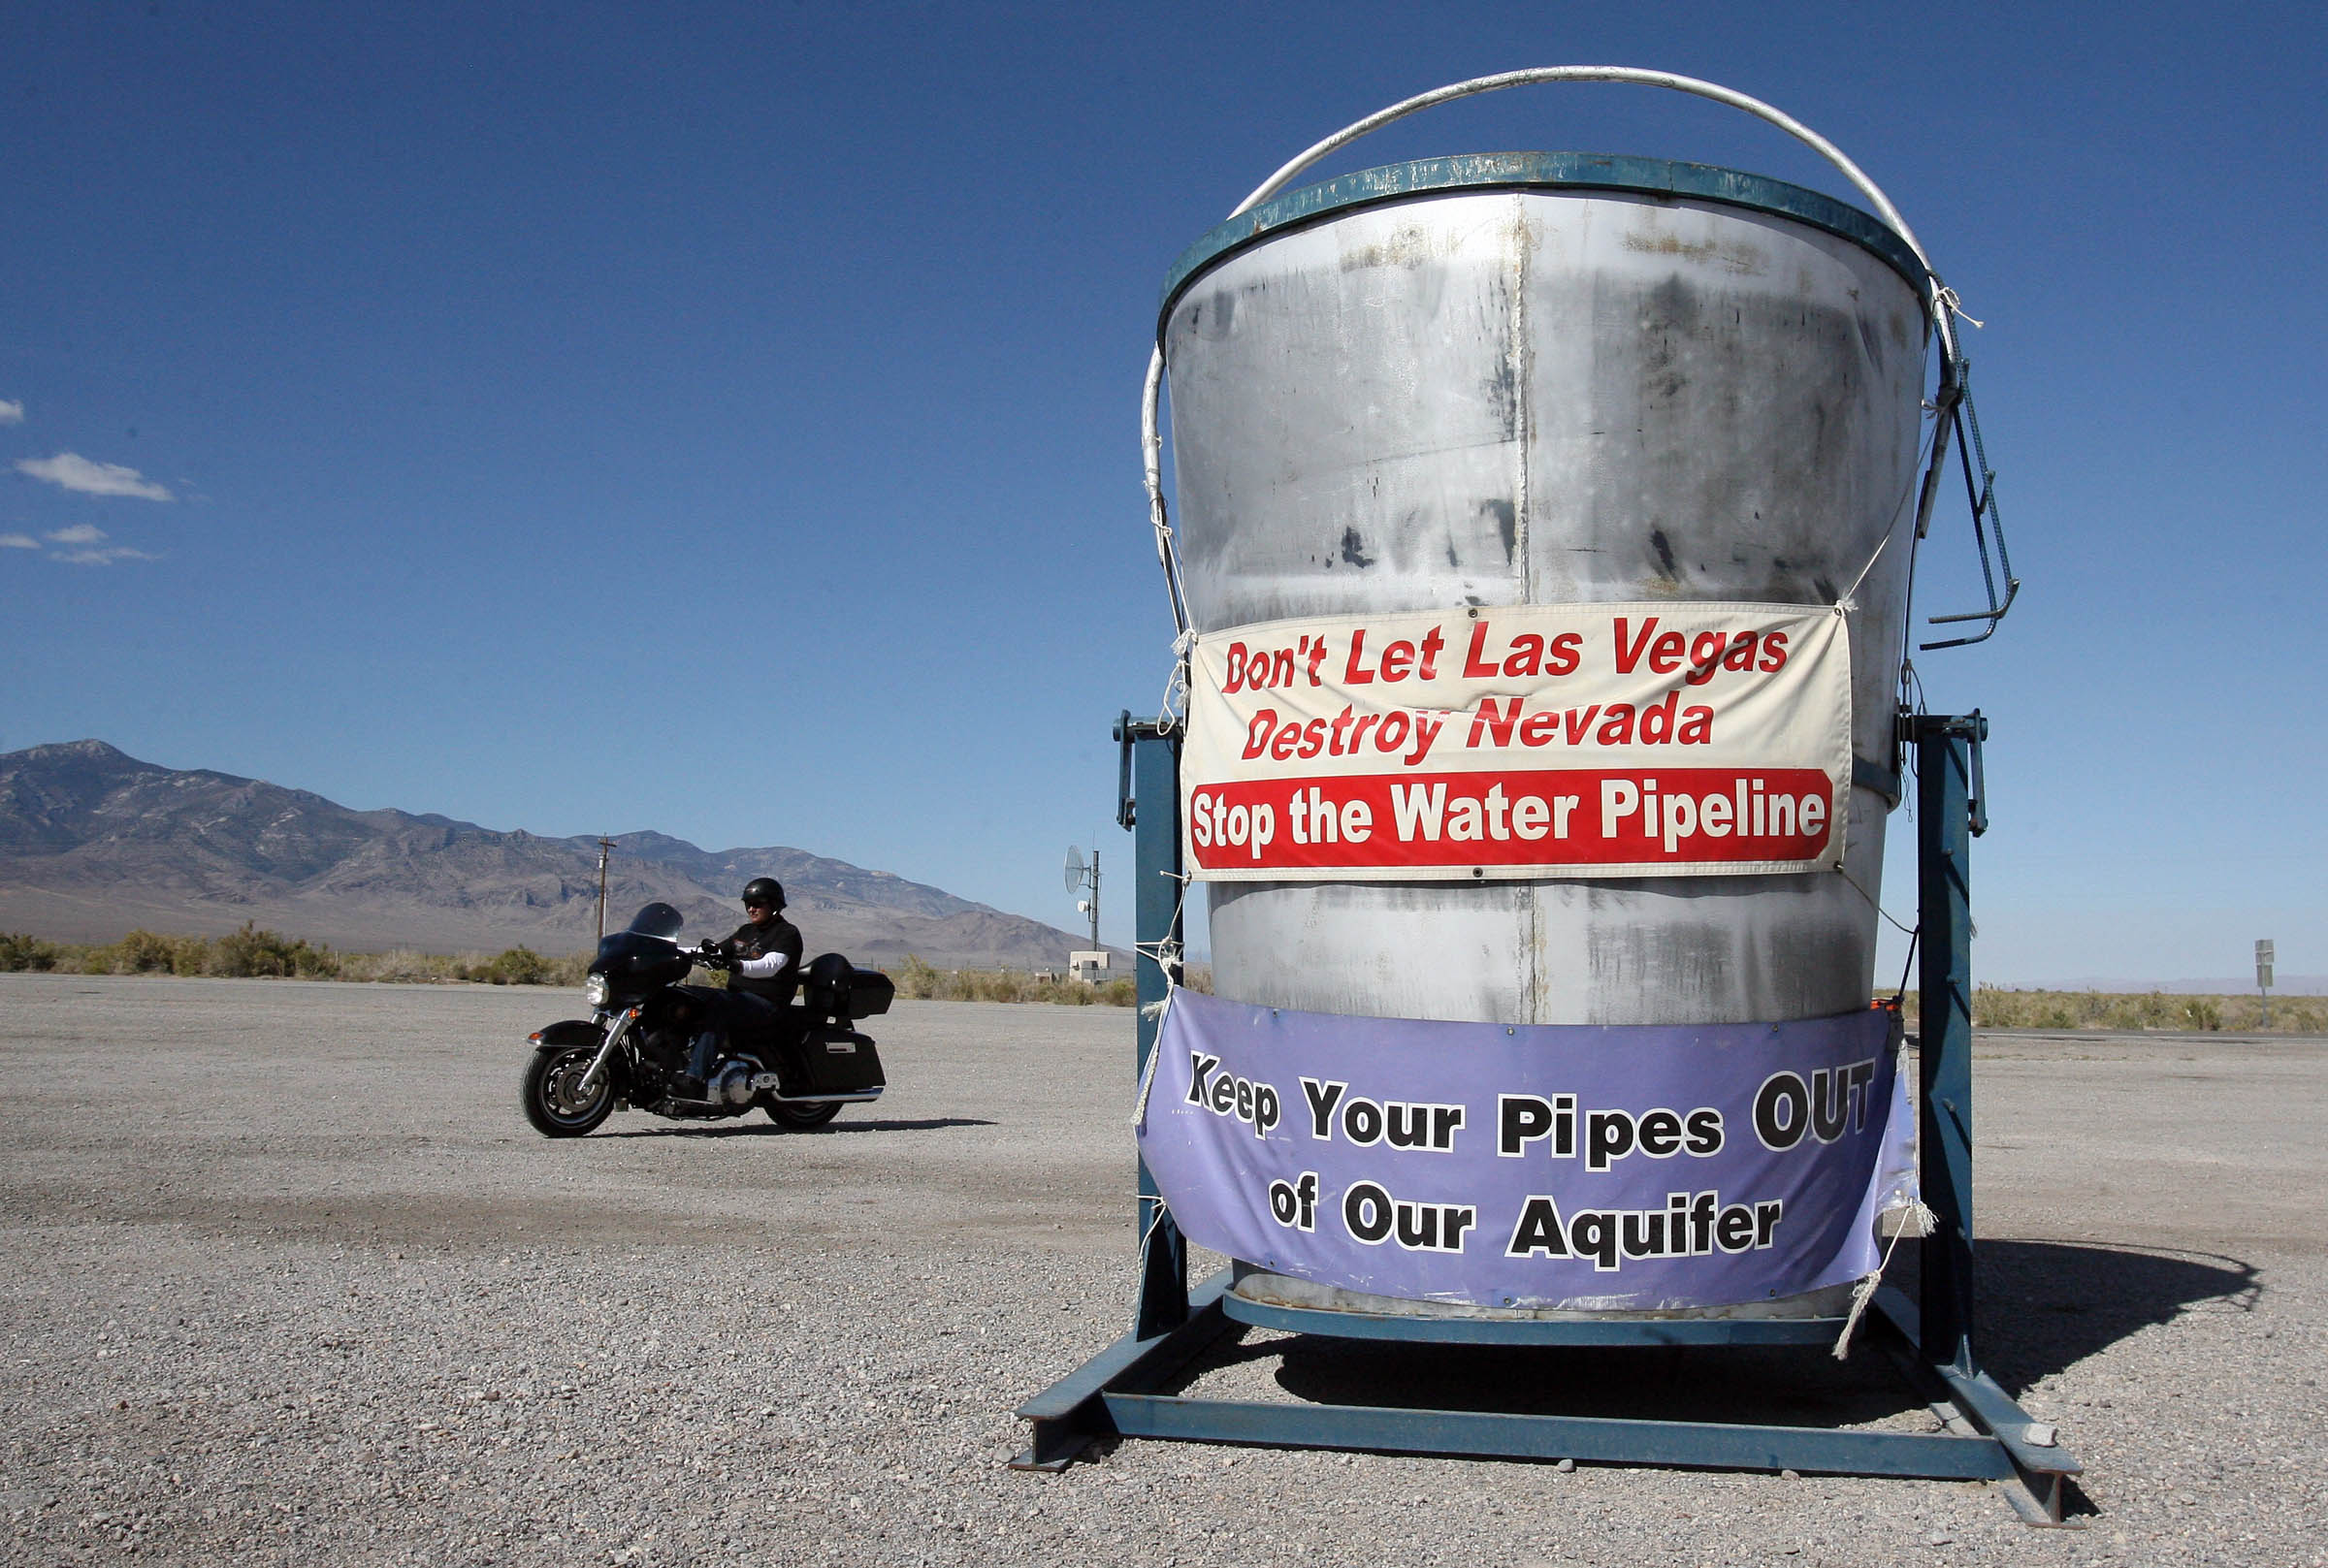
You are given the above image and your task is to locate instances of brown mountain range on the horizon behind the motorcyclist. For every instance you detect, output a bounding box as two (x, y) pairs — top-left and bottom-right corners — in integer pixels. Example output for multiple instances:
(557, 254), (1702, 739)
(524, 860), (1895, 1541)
(0, 740), (1087, 968)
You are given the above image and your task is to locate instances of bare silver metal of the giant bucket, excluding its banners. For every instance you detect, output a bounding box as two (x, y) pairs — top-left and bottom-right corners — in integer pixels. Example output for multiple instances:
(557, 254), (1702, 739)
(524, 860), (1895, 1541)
(1162, 153), (1925, 1024)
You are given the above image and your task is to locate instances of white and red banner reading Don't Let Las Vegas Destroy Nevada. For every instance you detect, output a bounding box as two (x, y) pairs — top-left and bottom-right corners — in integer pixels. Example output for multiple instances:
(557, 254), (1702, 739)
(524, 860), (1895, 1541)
(1180, 602), (1851, 881)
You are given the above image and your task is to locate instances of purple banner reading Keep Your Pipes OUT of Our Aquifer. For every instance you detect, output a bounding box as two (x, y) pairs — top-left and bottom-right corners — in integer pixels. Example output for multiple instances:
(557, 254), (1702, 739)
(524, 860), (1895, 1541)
(1139, 991), (1914, 1310)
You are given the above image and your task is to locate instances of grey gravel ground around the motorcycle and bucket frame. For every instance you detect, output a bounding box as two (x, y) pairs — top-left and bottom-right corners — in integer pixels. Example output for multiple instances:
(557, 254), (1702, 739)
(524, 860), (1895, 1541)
(0, 975), (2328, 1568)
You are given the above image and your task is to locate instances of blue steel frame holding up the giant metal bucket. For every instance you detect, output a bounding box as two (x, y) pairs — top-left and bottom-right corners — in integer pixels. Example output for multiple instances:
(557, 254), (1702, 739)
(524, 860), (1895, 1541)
(1011, 712), (2082, 1523)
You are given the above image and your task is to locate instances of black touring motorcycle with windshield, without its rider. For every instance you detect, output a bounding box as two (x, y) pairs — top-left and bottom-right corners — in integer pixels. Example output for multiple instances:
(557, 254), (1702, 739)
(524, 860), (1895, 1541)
(519, 903), (896, 1137)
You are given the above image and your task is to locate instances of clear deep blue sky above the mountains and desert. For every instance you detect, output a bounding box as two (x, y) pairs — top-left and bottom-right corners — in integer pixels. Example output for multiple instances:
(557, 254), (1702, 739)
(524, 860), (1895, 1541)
(0, 0), (2328, 981)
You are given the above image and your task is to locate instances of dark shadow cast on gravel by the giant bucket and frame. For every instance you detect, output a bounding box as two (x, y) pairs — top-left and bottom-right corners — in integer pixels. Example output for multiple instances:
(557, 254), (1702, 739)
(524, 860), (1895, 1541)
(1189, 1240), (2260, 1430)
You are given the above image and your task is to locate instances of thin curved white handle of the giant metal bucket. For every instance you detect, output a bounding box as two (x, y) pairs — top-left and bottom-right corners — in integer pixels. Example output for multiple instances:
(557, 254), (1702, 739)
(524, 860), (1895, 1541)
(1141, 65), (1956, 633)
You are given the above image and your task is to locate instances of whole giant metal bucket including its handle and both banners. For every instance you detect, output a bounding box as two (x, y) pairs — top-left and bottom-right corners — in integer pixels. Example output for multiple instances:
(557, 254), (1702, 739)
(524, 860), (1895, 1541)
(1141, 68), (1946, 1317)
